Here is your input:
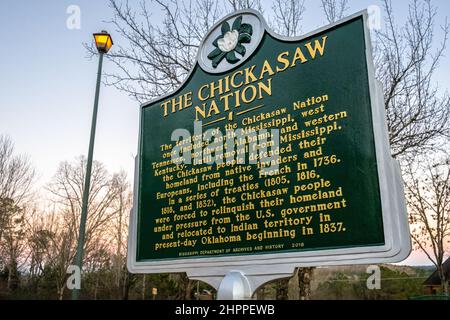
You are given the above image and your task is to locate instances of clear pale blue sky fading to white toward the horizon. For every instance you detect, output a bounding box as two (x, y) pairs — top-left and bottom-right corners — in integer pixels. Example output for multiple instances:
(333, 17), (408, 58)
(0, 0), (450, 264)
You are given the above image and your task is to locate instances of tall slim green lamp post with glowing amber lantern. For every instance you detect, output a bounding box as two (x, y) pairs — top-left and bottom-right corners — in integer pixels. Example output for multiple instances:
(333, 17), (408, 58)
(72, 31), (113, 300)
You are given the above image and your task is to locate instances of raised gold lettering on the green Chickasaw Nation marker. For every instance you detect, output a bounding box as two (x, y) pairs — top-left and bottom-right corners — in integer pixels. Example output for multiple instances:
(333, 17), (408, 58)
(149, 32), (352, 257)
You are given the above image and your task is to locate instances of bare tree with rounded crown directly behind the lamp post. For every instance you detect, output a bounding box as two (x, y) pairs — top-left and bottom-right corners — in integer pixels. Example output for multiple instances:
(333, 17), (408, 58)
(48, 157), (119, 299)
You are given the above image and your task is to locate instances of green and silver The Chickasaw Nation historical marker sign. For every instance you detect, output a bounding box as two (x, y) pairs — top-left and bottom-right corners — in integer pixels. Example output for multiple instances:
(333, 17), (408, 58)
(128, 11), (410, 282)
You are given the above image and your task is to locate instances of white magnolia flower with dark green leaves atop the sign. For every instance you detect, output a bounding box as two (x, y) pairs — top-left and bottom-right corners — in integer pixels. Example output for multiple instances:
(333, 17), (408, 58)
(208, 16), (253, 68)
